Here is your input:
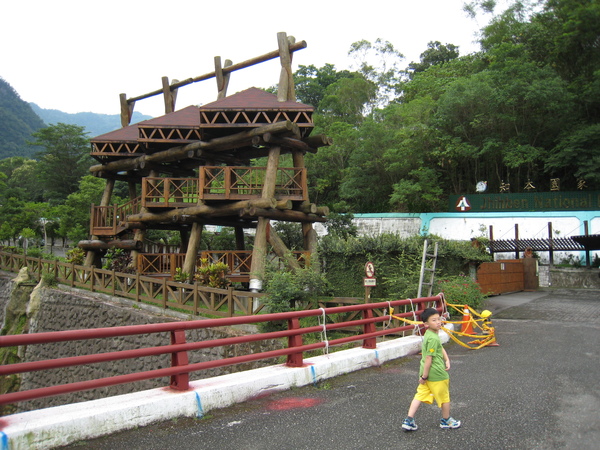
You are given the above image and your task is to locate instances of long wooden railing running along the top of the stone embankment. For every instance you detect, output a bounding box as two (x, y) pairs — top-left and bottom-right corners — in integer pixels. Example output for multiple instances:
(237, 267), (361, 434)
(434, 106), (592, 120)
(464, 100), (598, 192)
(0, 251), (265, 317)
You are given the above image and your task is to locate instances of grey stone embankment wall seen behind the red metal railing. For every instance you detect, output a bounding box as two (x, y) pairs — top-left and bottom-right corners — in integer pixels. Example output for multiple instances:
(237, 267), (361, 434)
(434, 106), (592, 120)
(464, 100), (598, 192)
(0, 272), (282, 411)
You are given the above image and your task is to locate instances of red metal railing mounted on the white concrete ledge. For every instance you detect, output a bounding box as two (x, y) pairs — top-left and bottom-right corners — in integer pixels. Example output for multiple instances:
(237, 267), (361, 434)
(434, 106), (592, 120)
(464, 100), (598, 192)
(0, 295), (444, 404)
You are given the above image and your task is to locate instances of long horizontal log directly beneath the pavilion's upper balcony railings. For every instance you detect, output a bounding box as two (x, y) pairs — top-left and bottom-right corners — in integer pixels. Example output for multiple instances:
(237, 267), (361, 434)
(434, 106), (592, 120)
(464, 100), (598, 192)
(126, 198), (277, 223)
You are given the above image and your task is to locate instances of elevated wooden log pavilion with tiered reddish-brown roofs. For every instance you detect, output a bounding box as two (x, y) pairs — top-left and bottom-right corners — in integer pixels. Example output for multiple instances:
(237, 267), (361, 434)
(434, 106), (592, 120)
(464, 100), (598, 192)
(80, 33), (331, 290)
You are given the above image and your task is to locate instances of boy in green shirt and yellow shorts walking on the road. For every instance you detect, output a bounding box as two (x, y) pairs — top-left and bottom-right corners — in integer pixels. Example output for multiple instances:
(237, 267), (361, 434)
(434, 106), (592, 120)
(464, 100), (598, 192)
(402, 308), (460, 431)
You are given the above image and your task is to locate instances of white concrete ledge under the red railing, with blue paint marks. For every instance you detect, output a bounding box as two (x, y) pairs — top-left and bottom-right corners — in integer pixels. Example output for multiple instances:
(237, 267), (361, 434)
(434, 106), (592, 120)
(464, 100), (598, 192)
(0, 332), (449, 450)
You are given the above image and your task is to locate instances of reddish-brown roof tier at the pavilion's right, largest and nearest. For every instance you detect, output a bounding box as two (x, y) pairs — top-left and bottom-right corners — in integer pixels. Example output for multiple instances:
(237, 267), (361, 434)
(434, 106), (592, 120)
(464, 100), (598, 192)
(199, 87), (314, 111)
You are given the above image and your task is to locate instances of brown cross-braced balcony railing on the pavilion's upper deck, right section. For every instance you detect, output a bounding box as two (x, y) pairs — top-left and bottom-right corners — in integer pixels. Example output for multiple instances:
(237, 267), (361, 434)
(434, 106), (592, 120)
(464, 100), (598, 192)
(200, 166), (308, 200)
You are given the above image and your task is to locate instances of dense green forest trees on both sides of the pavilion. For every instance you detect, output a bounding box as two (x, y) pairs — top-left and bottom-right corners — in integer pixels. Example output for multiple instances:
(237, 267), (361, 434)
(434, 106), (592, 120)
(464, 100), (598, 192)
(0, 0), (600, 248)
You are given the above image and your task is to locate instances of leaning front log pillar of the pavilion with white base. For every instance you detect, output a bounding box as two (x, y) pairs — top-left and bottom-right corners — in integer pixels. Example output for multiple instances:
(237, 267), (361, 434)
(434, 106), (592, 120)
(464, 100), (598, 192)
(250, 147), (281, 292)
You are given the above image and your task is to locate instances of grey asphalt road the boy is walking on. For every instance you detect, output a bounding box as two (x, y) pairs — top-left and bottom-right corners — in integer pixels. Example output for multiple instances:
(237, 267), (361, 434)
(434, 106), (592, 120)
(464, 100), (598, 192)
(71, 290), (600, 450)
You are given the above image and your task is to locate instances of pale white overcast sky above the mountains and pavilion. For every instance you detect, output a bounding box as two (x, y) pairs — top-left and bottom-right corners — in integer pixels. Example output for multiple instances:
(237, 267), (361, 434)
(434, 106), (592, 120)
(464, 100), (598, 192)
(0, 0), (496, 116)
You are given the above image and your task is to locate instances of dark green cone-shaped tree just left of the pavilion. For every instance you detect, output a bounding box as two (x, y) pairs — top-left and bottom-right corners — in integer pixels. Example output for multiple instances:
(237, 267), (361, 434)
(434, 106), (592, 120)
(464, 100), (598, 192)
(32, 123), (92, 201)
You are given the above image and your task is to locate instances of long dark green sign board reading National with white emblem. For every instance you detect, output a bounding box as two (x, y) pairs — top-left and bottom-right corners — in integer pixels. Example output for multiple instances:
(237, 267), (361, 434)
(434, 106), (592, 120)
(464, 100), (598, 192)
(449, 191), (600, 212)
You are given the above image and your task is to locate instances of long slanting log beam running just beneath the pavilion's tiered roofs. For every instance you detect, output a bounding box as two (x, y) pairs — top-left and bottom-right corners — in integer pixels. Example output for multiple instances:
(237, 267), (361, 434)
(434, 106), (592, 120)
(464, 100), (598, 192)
(90, 120), (300, 173)
